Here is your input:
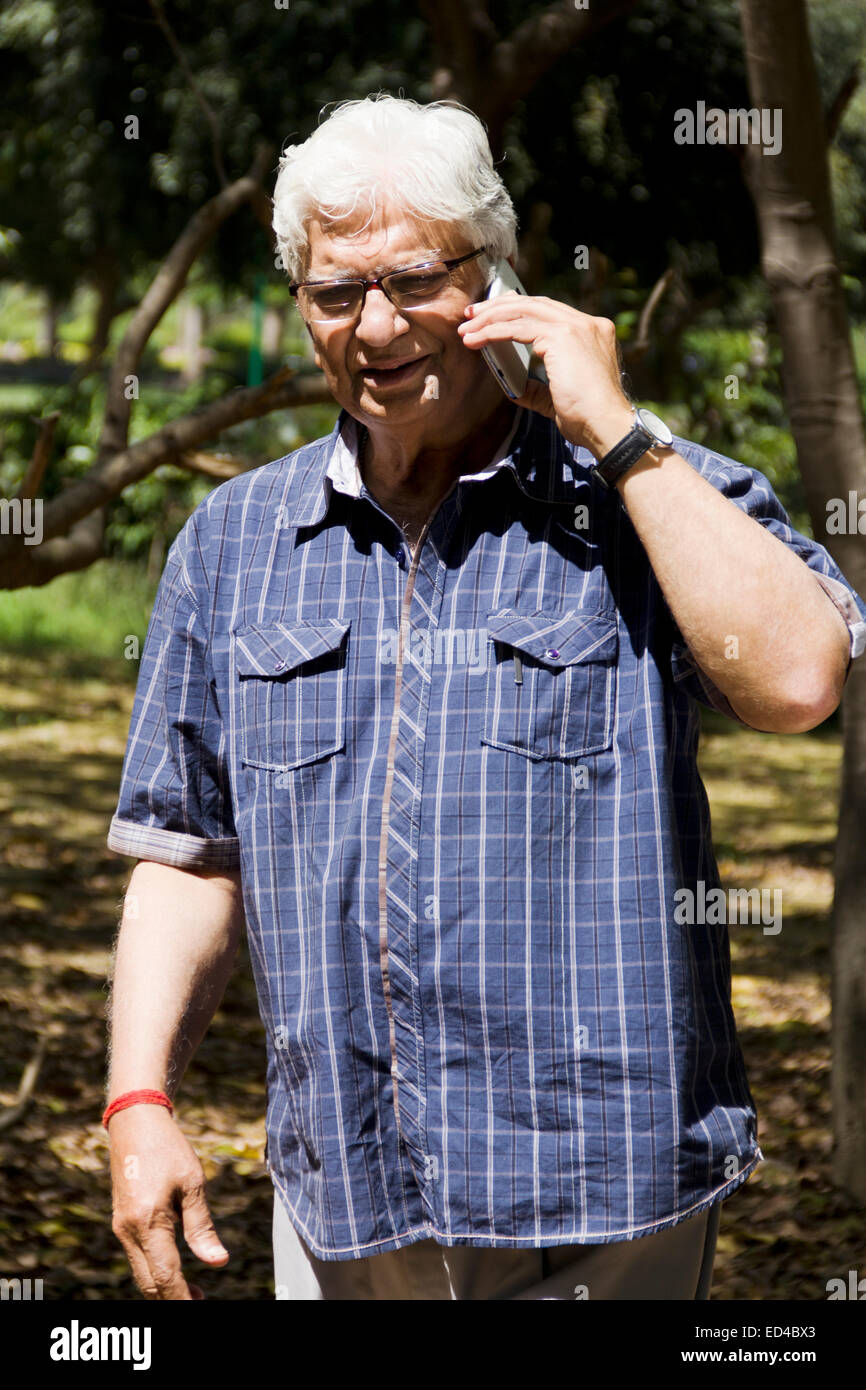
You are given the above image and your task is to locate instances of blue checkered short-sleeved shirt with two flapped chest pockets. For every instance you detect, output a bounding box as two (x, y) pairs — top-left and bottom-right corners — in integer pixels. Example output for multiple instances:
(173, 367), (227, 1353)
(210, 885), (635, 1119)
(108, 410), (866, 1259)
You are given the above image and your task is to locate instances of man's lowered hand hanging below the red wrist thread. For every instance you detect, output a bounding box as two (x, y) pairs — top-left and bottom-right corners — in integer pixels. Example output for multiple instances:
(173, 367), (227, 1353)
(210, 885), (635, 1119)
(108, 1105), (229, 1298)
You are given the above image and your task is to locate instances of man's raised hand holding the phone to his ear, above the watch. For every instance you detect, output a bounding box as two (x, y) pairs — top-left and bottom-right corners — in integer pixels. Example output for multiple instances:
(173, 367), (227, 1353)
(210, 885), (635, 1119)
(457, 292), (632, 459)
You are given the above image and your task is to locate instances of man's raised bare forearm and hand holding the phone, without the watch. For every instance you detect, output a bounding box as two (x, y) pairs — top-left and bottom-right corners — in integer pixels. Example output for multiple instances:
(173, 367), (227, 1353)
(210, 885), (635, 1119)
(457, 295), (851, 733)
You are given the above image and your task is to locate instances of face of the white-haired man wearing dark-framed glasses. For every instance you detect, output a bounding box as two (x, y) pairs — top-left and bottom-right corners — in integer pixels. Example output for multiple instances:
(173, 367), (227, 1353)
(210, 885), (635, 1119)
(304, 207), (498, 436)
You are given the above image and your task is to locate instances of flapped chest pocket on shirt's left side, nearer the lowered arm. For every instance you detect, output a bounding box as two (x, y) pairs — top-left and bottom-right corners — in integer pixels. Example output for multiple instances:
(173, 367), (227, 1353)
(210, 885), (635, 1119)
(235, 619), (350, 771)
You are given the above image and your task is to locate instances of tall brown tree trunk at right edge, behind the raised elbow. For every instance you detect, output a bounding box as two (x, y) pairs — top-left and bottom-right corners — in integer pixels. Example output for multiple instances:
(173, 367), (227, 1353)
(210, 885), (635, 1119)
(741, 0), (866, 1201)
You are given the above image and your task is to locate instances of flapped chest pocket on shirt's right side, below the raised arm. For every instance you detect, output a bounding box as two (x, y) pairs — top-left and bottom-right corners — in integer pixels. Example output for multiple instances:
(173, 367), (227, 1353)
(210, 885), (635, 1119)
(481, 609), (619, 760)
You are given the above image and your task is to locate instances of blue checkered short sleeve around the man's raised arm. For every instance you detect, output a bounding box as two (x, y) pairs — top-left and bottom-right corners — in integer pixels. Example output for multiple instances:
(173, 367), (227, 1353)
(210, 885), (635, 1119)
(669, 436), (866, 724)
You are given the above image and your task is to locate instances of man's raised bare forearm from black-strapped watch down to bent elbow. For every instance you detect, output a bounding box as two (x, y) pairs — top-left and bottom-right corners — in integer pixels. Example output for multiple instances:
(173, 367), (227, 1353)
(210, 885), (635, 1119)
(617, 449), (849, 733)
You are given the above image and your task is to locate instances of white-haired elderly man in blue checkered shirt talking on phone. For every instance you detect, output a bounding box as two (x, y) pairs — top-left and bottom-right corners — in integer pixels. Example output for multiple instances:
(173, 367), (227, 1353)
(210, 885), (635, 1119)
(106, 97), (866, 1300)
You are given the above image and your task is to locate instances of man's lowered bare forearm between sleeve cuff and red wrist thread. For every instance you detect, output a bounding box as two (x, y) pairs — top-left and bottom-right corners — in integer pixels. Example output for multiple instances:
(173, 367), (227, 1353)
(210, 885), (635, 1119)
(107, 860), (243, 1099)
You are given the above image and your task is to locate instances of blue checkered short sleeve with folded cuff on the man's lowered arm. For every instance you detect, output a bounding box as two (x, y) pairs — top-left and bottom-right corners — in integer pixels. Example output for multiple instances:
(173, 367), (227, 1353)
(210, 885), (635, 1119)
(108, 532), (239, 872)
